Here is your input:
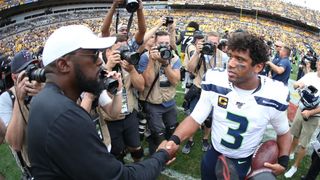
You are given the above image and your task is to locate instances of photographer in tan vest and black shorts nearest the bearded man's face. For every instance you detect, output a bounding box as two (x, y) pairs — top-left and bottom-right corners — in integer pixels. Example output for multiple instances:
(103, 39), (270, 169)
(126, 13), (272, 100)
(105, 35), (145, 162)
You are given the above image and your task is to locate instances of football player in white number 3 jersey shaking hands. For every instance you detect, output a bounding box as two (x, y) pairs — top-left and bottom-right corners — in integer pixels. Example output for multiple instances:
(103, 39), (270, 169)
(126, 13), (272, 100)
(167, 32), (291, 179)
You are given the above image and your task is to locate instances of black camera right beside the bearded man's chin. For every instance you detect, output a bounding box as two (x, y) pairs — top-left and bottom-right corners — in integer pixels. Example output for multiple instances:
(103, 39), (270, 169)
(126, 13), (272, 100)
(99, 70), (119, 94)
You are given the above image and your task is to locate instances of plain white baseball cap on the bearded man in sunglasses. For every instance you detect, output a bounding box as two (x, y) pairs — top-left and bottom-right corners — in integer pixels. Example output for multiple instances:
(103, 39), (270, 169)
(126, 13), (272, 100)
(42, 25), (116, 66)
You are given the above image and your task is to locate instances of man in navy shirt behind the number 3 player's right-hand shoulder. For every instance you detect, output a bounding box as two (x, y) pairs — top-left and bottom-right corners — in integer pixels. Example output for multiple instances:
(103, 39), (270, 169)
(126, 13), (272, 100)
(267, 46), (291, 85)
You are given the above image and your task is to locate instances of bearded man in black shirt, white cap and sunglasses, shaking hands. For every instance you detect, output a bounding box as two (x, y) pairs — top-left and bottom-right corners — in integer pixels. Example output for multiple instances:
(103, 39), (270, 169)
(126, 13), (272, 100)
(27, 25), (174, 179)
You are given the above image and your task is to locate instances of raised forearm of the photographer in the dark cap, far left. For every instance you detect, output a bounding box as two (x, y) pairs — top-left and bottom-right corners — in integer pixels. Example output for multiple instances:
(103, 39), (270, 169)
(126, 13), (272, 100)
(6, 100), (28, 151)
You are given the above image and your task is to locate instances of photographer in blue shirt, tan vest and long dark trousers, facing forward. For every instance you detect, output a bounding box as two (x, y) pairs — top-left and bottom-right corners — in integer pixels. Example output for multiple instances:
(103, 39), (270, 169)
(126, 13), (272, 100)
(139, 31), (181, 154)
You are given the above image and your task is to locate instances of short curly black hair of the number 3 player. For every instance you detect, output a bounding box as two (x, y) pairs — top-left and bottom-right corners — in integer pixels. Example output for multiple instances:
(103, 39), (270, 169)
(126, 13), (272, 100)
(227, 32), (269, 66)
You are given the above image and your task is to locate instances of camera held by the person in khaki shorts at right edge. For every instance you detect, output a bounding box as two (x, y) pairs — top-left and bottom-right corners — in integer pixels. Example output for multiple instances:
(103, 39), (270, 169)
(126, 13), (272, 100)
(298, 85), (320, 121)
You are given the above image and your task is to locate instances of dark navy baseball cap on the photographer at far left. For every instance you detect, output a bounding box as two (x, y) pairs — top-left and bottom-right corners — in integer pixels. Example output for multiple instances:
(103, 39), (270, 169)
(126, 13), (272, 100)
(11, 50), (38, 74)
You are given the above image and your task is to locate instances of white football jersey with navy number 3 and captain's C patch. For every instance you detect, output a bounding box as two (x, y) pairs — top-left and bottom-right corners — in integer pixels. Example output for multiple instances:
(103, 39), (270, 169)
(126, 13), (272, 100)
(191, 70), (289, 158)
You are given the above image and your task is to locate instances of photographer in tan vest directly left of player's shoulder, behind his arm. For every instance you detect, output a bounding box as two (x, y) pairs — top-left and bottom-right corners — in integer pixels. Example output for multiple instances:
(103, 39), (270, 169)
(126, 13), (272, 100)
(182, 32), (228, 154)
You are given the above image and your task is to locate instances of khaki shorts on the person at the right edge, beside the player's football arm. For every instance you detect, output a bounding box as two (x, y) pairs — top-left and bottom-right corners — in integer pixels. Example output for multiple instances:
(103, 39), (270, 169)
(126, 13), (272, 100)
(290, 108), (319, 148)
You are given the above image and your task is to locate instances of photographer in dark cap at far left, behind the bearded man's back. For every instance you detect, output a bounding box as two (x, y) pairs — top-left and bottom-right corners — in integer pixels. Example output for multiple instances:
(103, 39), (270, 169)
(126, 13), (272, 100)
(0, 50), (42, 178)
